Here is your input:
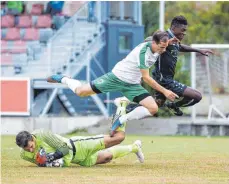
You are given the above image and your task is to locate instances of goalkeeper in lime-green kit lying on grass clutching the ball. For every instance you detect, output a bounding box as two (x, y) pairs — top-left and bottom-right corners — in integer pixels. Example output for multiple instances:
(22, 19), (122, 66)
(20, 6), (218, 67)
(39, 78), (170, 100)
(16, 102), (144, 167)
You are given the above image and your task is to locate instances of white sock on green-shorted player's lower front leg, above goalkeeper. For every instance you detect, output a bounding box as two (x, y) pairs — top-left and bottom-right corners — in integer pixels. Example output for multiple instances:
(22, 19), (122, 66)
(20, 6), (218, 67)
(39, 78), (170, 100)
(119, 106), (152, 123)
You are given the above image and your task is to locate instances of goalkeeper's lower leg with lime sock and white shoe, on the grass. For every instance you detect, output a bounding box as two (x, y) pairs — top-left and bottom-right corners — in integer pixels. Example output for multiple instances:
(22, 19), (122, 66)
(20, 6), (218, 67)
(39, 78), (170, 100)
(96, 140), (144, 164)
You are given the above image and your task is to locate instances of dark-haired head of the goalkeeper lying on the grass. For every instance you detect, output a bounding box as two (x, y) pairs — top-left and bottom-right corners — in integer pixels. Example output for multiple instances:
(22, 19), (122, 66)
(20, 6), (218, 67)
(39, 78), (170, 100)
(16, 131), (36, 153)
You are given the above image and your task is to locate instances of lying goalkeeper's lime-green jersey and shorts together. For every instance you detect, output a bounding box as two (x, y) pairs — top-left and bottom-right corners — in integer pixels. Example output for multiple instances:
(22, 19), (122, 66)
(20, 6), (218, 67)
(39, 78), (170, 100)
(21, 130), (105, 167)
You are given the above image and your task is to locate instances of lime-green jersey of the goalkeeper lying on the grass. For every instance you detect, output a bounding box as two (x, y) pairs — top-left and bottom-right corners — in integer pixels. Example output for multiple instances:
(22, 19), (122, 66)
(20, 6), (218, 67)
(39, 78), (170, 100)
(20, 130), (73, 166)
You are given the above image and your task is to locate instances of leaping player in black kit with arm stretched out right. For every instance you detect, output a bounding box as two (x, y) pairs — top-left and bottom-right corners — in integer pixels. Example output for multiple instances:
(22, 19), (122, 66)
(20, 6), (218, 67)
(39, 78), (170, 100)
(148, 16), (213, 116)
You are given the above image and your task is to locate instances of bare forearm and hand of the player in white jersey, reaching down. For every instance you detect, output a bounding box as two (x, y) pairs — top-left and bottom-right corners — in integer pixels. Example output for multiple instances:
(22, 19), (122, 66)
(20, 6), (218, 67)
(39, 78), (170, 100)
(141, 69), (179, 101)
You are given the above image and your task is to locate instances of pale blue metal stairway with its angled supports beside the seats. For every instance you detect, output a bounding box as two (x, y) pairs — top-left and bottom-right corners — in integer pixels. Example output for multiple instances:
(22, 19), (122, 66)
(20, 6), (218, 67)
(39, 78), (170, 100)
(30, 2), (108, 117)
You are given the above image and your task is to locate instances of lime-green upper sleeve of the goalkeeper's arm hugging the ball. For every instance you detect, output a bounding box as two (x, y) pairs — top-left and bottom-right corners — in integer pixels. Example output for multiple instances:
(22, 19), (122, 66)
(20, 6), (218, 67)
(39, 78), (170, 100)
(36, 130), (69, 156)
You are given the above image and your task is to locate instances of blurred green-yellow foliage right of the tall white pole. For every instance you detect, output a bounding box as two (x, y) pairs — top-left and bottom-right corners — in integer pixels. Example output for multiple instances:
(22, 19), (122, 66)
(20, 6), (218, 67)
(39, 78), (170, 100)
(165, 1), (229, 44)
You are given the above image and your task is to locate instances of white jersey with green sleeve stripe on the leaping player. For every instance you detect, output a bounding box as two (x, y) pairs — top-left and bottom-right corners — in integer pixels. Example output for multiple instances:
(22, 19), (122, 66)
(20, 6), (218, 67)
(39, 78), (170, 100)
(112, 42), (159, 84)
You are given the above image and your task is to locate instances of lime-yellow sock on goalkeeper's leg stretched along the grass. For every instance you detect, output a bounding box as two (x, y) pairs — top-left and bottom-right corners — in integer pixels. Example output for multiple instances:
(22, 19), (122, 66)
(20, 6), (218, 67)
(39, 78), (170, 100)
(108, 144), (138, 159)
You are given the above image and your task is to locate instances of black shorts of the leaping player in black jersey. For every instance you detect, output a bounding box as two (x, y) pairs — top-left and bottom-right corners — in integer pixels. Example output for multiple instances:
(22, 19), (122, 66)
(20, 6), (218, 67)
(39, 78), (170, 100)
(155, 79), (187, 100)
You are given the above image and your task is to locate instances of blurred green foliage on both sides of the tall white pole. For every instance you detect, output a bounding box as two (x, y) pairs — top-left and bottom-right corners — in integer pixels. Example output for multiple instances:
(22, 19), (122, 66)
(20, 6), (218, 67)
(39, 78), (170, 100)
(142, 1), (229, 44)
